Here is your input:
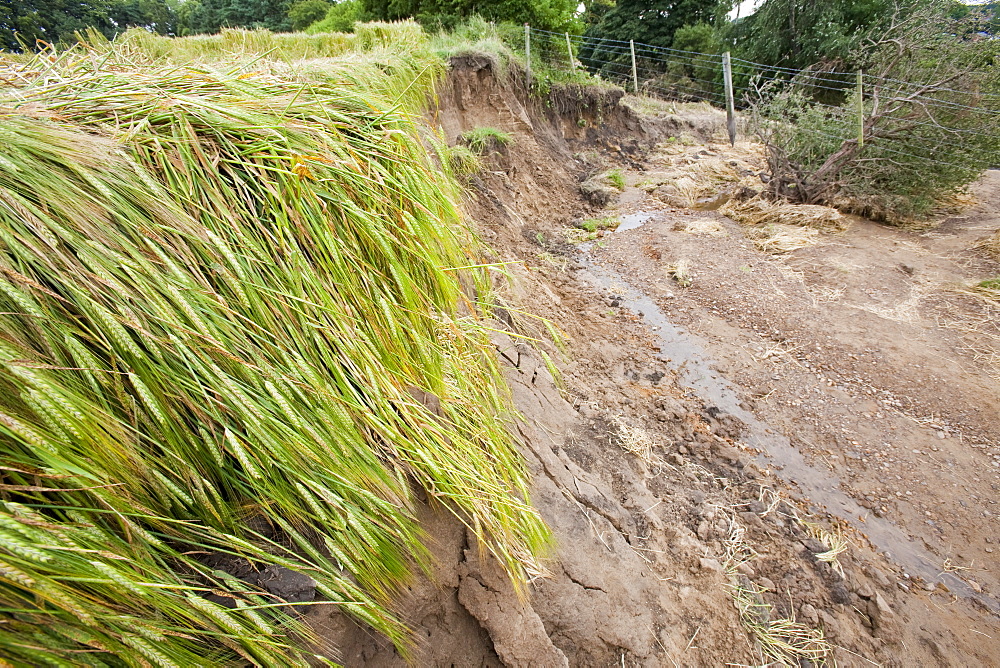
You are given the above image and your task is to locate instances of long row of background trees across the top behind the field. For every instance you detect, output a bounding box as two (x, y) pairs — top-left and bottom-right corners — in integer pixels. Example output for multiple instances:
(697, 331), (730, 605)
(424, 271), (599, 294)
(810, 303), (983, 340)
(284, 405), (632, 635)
(0, 0), (1000, 70)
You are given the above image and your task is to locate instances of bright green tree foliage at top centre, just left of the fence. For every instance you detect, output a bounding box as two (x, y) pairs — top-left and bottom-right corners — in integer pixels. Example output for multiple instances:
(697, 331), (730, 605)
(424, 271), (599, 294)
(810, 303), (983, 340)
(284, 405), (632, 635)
(362, 0), (579, 33)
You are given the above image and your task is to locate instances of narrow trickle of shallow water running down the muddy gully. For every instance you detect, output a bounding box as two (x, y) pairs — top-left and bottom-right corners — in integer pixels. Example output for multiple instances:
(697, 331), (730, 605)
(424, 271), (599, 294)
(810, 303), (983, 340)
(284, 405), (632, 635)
(579, 226), (1000, 611)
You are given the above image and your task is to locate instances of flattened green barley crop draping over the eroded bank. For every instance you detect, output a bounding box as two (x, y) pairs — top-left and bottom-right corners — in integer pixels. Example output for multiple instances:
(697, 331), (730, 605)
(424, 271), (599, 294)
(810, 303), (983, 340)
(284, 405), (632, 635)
(0, 35), (547, 666)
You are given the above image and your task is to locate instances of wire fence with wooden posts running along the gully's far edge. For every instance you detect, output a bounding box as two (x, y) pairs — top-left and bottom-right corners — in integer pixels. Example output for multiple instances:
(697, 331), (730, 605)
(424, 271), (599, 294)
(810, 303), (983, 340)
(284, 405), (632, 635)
(525, 26), (1000, 174)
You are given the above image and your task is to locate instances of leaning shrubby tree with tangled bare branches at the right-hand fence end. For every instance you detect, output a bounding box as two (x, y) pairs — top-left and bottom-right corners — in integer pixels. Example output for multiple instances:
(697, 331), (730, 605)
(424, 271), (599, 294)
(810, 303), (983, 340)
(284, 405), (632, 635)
(754, 1), (1000, 220)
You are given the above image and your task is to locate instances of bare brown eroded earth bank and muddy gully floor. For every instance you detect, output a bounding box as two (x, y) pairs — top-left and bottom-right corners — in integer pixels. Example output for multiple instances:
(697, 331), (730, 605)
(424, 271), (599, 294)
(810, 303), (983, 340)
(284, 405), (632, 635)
(311, 58), (1000, 666)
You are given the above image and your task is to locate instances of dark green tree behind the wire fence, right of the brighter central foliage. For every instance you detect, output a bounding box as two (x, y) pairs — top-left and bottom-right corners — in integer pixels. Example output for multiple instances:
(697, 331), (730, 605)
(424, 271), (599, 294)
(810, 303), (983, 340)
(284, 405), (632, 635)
(580, 0), (730, 79)
